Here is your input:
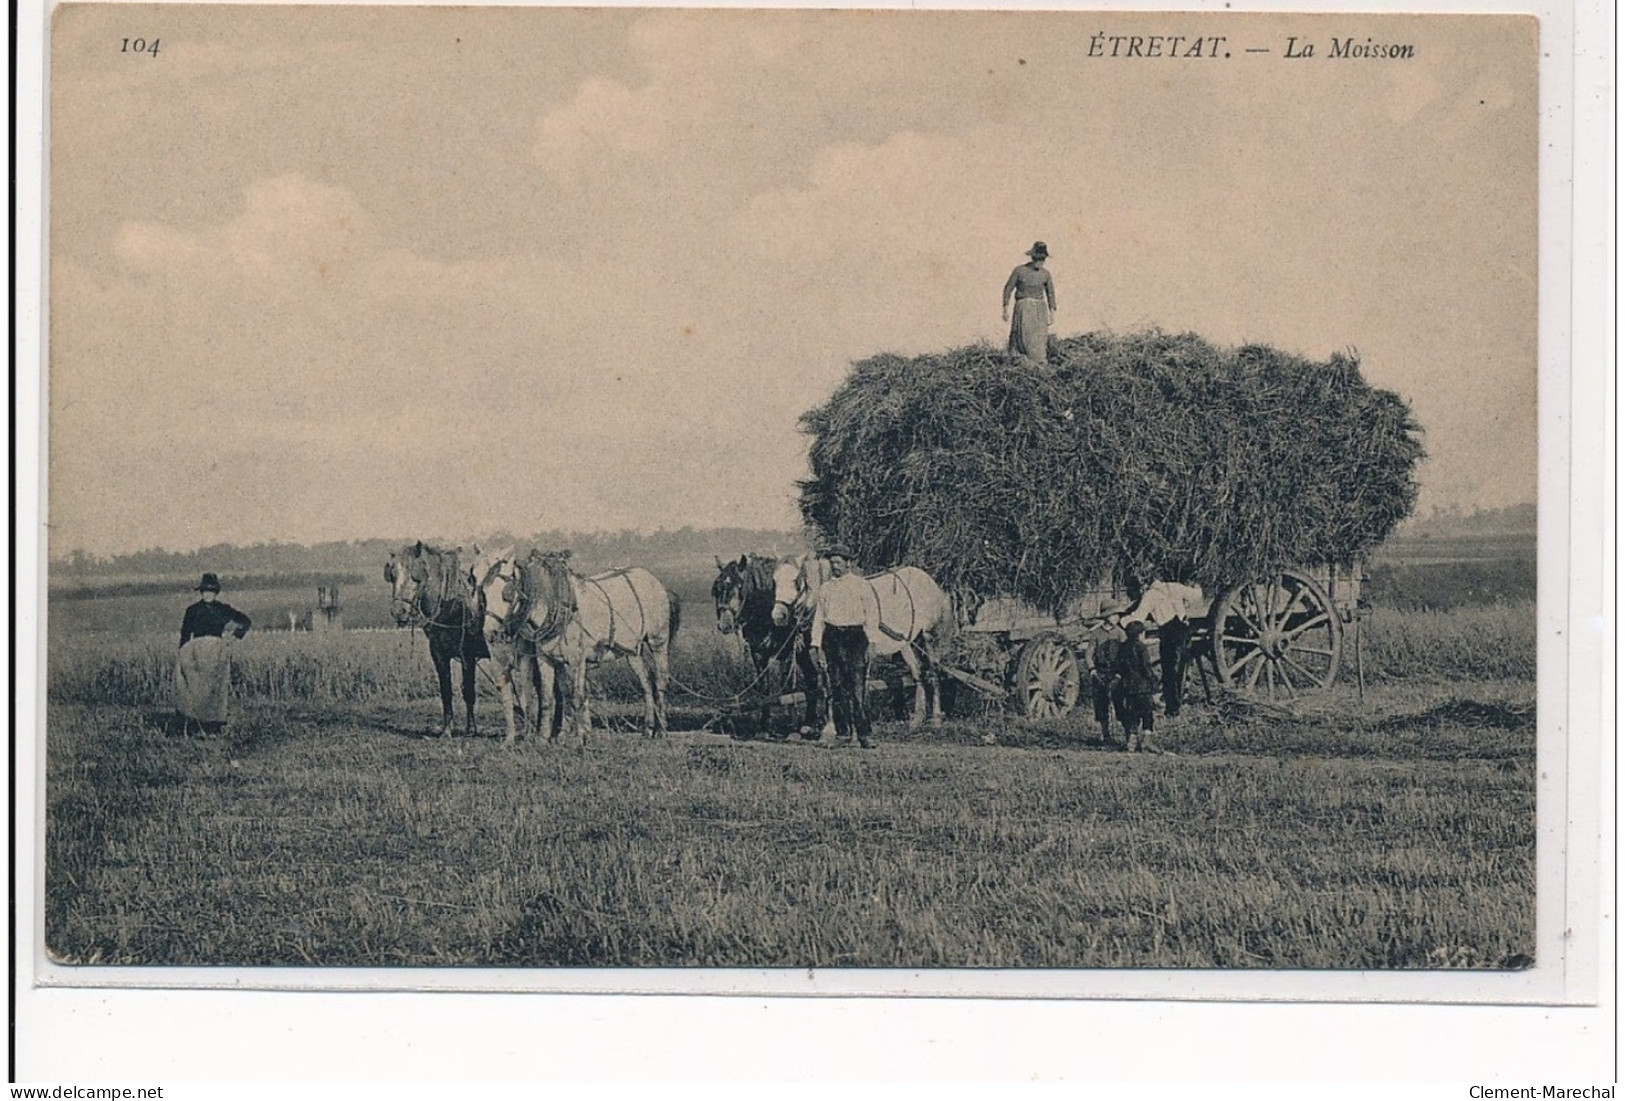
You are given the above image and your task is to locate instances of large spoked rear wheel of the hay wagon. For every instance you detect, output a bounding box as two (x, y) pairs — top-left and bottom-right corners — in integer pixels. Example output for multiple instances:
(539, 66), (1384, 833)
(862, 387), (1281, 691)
(1212, 570), (1342, 700)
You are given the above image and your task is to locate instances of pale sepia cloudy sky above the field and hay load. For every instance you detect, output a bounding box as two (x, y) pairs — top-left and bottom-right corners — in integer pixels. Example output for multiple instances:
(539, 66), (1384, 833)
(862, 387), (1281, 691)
(47, 5), (1537, 555)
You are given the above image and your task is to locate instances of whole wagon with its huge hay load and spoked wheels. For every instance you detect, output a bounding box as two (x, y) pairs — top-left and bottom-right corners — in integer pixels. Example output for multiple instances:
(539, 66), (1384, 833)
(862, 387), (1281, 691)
(801, 330), (1424, 718)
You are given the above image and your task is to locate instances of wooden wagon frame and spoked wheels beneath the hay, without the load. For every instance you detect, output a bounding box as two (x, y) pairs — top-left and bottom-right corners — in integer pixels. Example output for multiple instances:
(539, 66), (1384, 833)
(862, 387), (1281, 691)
(943, 567), (1363, 718)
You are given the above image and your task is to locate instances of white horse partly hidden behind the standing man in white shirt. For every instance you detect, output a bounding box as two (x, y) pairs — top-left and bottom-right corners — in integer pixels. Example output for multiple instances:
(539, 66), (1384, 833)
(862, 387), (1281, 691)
(774, 554), (959, 729)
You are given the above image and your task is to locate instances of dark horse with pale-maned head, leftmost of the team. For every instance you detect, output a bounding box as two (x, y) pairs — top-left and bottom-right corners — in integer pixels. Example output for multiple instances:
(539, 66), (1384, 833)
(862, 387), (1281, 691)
(384, 541), (491, 737)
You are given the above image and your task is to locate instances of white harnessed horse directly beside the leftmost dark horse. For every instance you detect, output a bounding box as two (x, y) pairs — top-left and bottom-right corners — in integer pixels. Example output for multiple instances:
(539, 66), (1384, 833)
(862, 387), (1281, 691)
(481, 551), (683, 742)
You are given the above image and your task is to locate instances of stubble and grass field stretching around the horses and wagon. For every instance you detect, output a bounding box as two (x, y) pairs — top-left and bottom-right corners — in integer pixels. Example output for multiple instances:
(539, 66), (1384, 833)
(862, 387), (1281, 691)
(44, 542), (1536, 968)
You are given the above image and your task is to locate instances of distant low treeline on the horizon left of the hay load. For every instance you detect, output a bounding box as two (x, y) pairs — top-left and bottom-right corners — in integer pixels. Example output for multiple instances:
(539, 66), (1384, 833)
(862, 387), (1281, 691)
(50, 528), (804, 583)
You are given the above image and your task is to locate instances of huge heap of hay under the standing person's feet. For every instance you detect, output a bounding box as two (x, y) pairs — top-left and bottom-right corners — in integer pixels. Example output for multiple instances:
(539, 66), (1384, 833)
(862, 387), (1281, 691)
(801, 330), (1424, 611)
